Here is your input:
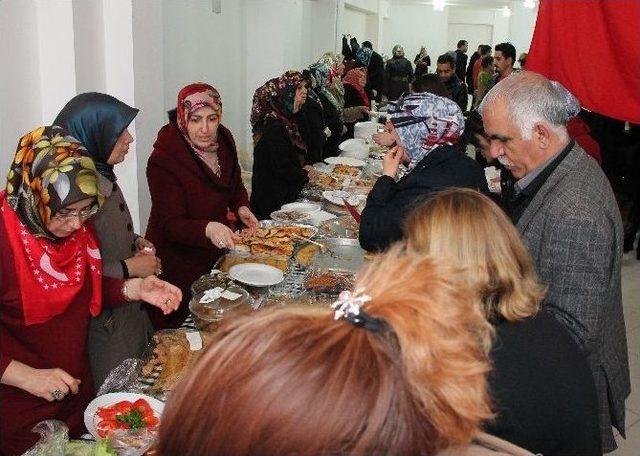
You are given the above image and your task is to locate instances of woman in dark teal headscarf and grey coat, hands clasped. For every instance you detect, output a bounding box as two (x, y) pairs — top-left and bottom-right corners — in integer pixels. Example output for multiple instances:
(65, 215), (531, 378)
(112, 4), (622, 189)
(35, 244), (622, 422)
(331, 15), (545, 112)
(53, 92), (161, 389)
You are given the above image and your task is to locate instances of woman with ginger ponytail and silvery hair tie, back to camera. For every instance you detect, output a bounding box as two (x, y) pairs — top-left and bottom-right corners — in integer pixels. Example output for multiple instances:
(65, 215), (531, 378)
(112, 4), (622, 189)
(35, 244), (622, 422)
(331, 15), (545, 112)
(158, 247), (530, 456)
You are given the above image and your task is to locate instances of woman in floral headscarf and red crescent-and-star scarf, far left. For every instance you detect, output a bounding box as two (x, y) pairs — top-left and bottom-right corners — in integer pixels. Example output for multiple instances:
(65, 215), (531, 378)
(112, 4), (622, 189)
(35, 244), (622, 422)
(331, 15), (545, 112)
(0, 126), (182, 456)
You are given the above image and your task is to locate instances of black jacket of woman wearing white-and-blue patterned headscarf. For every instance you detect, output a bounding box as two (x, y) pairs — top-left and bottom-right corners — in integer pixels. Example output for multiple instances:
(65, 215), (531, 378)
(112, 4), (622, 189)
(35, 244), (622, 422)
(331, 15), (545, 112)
(360, 146), (489, 251)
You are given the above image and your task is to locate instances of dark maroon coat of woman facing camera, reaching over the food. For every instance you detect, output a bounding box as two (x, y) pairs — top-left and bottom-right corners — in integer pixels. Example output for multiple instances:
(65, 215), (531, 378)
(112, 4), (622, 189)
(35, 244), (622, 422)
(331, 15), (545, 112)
(146, 123), (249, 329)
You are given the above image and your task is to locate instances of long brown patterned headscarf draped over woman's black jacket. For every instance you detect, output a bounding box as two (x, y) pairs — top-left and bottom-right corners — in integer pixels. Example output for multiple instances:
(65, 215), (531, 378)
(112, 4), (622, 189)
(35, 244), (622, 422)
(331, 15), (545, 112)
(250, 71), (307, 150)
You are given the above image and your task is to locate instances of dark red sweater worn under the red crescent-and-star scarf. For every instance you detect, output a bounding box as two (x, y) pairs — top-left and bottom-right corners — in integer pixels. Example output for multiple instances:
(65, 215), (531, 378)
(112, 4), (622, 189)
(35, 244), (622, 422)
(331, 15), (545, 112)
(0, 218), (123, 456)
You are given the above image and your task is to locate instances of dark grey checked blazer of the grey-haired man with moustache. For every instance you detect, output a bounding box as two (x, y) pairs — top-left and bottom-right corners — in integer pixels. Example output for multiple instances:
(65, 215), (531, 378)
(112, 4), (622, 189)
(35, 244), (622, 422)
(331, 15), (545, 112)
(517, 145), (631, 451)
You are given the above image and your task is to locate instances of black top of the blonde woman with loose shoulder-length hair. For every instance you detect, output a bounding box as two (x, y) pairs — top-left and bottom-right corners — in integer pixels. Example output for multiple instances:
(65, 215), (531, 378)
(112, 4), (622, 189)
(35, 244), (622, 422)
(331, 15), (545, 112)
(486, 310), (602, 456)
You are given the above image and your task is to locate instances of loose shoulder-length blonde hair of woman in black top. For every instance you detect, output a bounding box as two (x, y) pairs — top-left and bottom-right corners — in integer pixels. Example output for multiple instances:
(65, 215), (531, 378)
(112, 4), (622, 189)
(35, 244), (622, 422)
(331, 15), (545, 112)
(405, 189), (545, 321)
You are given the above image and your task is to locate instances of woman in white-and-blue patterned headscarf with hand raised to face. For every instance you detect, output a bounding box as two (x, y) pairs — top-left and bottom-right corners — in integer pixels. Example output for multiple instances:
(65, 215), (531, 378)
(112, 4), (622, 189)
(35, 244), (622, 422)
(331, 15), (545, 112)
(360, 92), (489, 251)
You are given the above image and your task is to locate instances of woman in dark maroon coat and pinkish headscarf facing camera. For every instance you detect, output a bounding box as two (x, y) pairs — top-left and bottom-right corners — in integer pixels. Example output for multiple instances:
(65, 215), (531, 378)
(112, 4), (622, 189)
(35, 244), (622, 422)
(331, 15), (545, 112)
(146, 83), (258, 329)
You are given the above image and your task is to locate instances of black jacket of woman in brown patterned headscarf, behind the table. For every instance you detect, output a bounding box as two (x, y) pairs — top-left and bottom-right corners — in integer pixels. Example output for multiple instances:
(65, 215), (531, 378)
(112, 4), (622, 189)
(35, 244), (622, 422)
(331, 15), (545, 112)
(249, 122), (309, 220)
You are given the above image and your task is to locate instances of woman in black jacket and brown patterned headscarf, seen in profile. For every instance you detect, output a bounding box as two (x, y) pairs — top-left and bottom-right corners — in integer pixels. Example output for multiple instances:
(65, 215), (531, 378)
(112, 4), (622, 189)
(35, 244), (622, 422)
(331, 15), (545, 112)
(251, 71), (313, 219)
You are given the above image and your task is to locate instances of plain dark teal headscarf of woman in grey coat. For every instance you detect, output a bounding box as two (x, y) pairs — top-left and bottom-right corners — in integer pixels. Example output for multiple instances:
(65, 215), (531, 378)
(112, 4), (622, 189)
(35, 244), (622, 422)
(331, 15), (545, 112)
(53, 92), (138, 182)
